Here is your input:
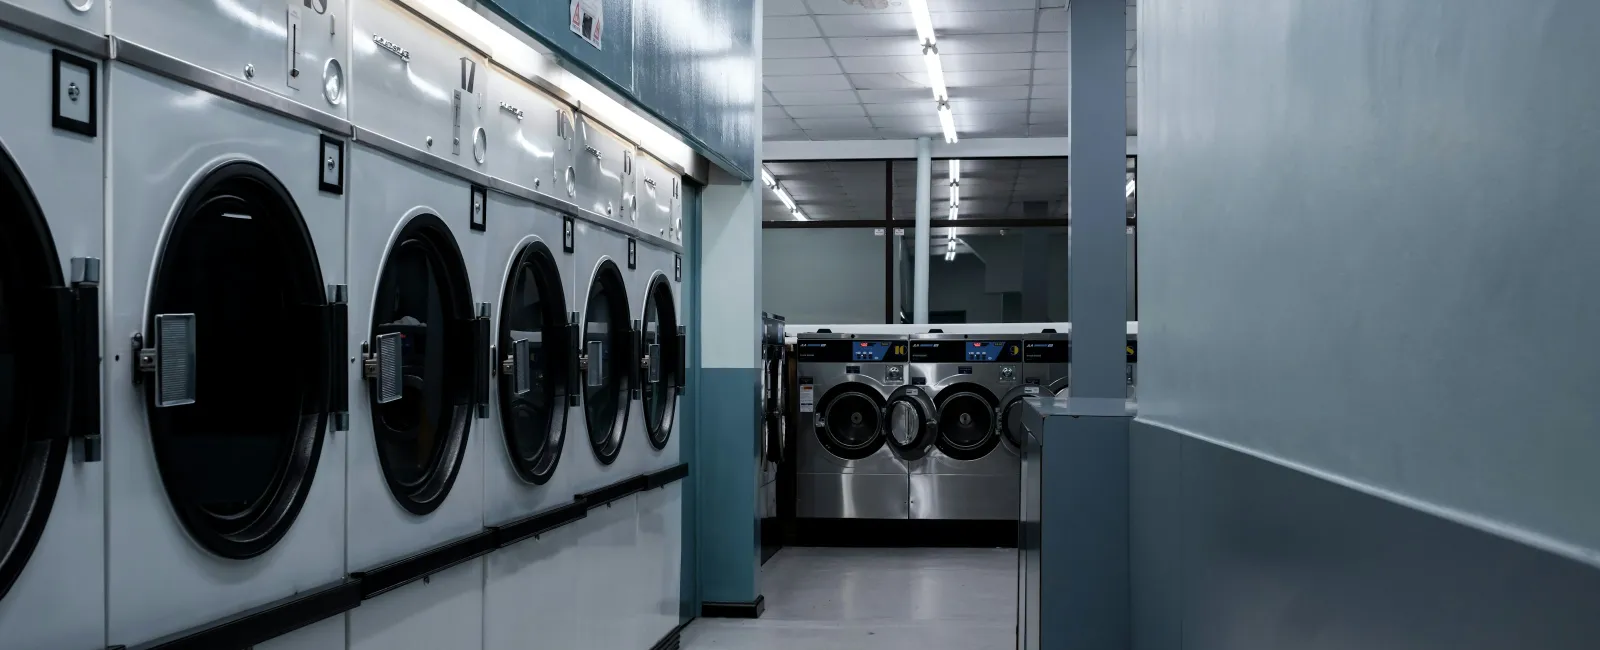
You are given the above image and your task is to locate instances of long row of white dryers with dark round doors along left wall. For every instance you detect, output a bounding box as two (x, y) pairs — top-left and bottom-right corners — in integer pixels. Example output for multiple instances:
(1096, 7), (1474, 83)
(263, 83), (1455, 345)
(0, 0), (686, 650)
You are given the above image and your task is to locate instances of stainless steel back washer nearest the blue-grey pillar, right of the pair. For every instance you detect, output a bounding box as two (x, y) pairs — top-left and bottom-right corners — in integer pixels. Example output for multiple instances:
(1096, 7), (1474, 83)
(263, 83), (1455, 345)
(909, 333), (1026, 522)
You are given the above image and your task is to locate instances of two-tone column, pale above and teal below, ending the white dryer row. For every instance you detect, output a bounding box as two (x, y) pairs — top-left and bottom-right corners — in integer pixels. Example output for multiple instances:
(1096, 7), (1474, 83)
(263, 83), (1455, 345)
(686, 0), (765, 618)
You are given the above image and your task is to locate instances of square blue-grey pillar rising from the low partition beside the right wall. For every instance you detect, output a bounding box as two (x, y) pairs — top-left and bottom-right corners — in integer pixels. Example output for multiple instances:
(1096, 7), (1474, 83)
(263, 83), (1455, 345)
(1067, 0), (1128, 402)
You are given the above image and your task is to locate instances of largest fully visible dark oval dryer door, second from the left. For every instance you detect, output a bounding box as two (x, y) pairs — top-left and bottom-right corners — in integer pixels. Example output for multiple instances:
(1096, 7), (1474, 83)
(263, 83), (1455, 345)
(139, 162), (346, 559)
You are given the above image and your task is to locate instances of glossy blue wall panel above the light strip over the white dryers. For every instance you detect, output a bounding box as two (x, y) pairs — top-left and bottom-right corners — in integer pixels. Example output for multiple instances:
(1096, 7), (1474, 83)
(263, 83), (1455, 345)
(480, 0), (762, 179)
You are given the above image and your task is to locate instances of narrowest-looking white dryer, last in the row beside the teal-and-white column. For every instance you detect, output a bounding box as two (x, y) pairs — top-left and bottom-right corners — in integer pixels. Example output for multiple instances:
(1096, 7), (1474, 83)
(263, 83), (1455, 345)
(624, 150), (688, 647)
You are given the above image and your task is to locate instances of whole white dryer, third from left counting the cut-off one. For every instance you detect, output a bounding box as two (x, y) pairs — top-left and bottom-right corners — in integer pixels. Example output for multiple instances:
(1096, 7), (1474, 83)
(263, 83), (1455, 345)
(344, 0), (483, 648)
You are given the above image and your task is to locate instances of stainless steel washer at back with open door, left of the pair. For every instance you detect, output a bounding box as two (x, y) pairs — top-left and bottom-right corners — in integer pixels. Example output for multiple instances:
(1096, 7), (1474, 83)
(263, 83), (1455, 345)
(795, 331), (938, 520)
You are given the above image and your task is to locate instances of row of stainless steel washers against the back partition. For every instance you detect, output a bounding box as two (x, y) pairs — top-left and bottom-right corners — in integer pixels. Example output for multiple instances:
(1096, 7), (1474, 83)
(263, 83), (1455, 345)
(795, 330), (1136, 520)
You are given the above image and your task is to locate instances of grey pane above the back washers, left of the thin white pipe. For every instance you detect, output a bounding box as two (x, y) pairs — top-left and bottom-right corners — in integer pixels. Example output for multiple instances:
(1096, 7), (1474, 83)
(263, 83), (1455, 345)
(764, 227), (883, 323)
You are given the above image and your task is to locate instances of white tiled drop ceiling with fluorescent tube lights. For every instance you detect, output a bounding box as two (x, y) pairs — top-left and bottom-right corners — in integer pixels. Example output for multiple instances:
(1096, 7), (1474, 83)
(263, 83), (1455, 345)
(762, 0), (1138, 139)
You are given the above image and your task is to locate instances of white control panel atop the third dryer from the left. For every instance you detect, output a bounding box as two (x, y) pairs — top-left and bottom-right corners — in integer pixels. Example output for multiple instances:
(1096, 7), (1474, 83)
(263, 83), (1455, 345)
(350, 0), (490, 171)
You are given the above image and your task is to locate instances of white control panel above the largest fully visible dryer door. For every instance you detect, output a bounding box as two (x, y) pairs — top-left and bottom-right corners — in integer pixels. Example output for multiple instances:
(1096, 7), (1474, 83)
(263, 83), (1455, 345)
(112, 0), (350, 117)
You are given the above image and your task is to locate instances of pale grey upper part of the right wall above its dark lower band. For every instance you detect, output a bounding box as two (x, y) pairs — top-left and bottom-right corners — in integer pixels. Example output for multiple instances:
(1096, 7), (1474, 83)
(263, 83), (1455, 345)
(1138, 0), (1600, 557)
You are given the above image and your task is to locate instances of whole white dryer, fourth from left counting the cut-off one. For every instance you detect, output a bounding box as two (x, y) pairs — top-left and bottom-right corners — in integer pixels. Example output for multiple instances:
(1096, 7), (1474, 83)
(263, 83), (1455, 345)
(483, 66), (589, 650)
